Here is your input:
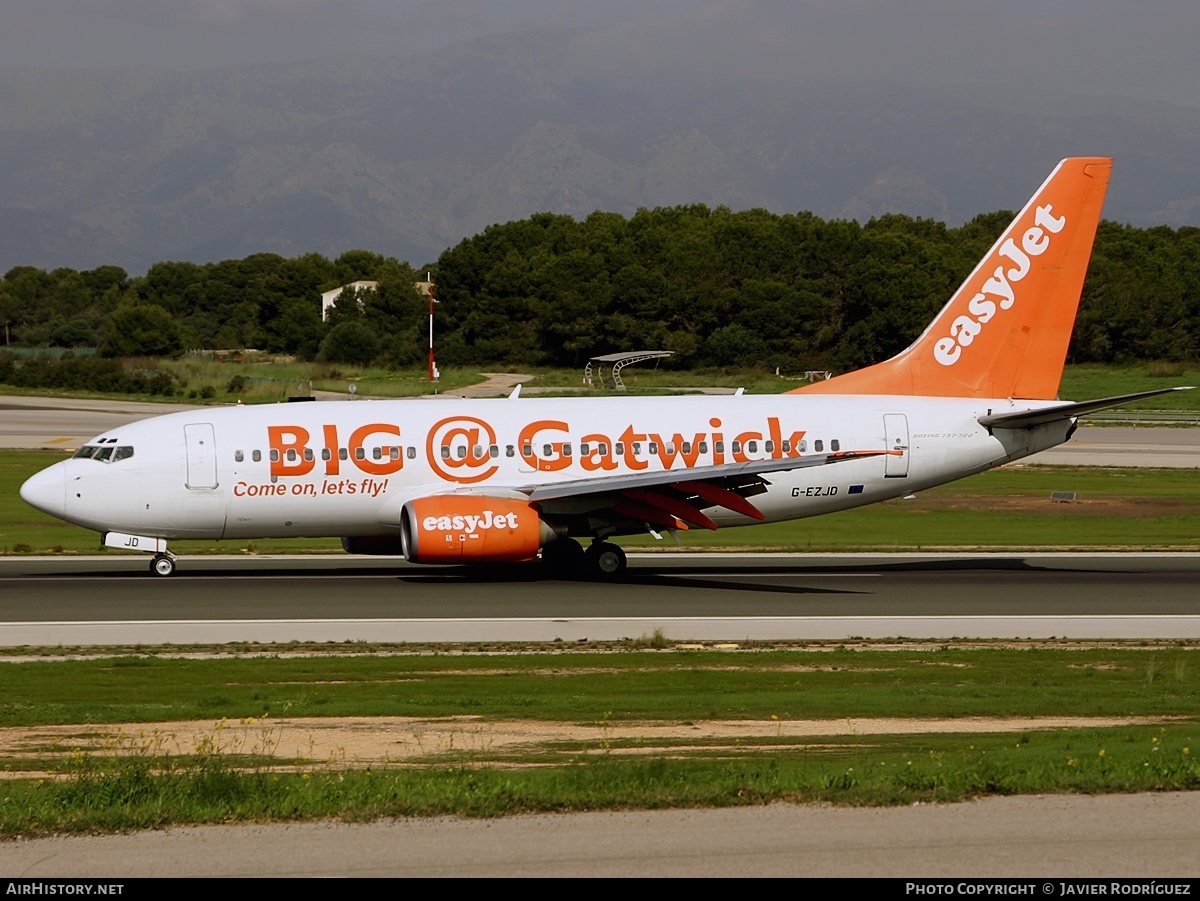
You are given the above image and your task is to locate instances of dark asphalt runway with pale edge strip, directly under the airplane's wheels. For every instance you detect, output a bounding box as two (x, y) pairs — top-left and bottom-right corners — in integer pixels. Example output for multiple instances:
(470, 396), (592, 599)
(0, 553), (1200, 647)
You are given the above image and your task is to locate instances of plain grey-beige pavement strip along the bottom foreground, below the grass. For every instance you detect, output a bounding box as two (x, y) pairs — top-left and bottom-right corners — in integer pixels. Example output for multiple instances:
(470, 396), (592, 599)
(0, 792), (1200, 878)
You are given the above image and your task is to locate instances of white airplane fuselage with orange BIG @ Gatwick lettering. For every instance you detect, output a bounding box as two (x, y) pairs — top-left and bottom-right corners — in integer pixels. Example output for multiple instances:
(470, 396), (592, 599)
(22, 395), (1073, 539)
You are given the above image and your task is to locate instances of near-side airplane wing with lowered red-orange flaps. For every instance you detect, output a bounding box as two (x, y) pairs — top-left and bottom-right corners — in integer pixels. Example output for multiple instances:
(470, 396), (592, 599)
(504, 450), (902, 529)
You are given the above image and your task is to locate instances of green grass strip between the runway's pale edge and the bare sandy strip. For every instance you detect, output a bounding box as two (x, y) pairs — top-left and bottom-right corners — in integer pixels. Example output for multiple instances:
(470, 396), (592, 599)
(0, 638), (1200, 729)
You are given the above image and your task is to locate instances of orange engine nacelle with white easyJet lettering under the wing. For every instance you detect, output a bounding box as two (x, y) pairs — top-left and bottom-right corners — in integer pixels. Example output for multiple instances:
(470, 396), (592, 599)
(400, 494), (554, 563)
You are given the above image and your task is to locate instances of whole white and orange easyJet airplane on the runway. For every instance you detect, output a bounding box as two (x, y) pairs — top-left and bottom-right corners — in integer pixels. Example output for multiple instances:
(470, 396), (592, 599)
(20, 157), (1186, 579)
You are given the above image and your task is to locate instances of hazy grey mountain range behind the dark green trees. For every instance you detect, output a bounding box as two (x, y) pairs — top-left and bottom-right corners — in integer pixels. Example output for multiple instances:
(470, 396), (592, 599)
(0, 32), (1200, 274)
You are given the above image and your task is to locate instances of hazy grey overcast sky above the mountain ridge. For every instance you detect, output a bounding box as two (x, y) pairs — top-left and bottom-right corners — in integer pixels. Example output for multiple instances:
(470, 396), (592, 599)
(0, 0), (1200, 107)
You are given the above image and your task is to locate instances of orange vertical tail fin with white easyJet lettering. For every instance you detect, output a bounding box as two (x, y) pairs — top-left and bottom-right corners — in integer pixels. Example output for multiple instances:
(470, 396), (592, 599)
(788, 157), (1112, 400)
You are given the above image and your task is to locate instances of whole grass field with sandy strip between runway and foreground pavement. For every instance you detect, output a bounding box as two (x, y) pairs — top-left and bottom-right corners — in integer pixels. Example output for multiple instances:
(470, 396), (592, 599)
(0, 645), (1200, 836)
